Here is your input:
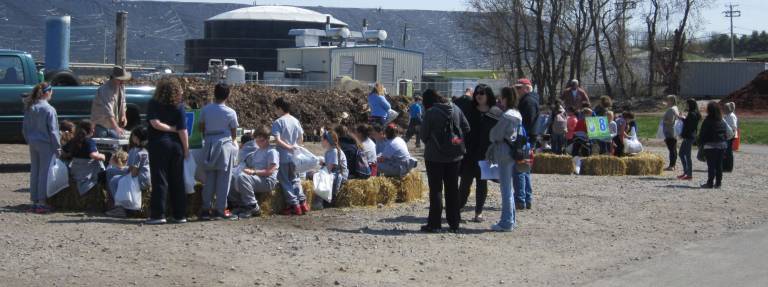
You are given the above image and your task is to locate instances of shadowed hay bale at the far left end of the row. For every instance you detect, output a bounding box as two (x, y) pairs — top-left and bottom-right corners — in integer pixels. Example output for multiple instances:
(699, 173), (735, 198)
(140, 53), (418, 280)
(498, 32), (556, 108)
(46, 180), (108, 213)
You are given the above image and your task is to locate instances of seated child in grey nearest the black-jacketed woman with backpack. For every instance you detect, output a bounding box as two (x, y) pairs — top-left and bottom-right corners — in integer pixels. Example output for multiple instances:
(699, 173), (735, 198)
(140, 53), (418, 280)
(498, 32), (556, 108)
(378, 125), (416, 177)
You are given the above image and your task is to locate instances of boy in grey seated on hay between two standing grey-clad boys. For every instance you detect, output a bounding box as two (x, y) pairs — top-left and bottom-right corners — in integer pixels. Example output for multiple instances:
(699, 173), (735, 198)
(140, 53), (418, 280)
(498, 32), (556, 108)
(229, 127), (280, 218)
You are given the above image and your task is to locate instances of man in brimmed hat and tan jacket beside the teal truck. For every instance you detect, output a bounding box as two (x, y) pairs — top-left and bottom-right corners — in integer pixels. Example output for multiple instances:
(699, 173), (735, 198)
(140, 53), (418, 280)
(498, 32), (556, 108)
(91, 66), (131, 138)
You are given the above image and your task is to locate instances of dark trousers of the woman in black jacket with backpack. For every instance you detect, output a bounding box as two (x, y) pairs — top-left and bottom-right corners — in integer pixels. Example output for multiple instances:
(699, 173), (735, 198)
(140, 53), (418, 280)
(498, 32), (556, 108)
(426, 161), (461, 229)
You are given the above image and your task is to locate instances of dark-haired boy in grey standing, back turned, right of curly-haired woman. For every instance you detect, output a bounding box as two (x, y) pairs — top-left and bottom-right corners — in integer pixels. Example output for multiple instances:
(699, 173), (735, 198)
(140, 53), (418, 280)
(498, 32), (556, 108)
(199, 84), (238, 220)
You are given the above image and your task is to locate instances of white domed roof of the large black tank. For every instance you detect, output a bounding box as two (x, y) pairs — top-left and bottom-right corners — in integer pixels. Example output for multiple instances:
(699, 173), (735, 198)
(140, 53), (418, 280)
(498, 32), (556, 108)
(208, 6), (349, 26)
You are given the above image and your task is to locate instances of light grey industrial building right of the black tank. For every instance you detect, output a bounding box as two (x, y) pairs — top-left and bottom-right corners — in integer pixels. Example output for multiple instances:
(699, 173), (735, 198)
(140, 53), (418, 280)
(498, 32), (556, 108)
(277, 46), (424, 92)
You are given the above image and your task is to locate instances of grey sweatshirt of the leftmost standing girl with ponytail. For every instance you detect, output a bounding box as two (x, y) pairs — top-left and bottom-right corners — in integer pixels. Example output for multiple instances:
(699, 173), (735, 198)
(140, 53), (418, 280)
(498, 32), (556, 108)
(21, 100), (61, 149)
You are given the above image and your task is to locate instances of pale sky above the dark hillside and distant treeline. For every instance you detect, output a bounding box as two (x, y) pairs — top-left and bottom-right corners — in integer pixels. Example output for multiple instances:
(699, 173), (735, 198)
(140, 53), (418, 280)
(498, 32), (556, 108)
(152, 0), (768, 34)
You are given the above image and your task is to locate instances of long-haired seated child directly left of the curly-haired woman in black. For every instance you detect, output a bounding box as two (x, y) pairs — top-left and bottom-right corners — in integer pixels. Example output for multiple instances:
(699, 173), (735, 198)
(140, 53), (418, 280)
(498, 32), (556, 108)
(106, 126), (150, 218)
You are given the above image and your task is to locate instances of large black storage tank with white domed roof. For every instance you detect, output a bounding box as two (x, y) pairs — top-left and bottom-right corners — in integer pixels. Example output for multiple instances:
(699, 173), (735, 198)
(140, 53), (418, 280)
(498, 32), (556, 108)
(184, 6), (347, 75)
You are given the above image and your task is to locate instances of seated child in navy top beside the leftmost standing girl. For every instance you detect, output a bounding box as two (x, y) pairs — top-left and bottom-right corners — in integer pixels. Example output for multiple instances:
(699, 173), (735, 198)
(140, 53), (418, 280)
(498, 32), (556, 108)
(64, 120), (105, 195)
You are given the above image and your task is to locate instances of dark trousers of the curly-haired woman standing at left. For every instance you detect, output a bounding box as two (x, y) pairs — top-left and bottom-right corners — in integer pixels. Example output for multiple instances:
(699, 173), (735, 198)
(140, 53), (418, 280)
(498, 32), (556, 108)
(147, 141), (187, 219)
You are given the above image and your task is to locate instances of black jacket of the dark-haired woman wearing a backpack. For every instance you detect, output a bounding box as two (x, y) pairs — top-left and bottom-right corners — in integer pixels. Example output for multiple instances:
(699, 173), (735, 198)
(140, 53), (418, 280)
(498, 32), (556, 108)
(420, 103), (470, 163)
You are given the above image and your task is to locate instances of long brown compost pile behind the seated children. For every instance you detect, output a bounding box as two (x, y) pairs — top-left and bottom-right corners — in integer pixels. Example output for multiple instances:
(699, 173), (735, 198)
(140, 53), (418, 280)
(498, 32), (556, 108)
(129, 78), (411, 137)
